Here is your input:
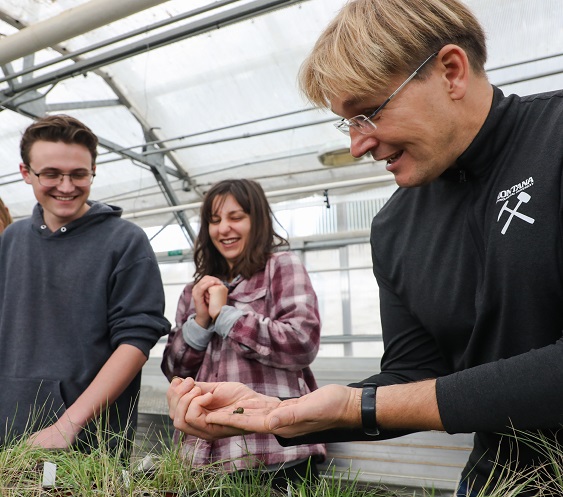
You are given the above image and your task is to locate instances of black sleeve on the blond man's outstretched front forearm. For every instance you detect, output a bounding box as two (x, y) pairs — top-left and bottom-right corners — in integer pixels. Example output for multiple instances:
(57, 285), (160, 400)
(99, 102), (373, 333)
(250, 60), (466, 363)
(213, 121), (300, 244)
(437, 340), (563, 433)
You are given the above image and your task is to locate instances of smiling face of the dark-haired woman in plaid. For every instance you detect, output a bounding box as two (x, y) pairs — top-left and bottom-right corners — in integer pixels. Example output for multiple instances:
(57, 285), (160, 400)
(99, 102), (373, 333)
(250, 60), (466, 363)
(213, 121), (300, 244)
(209, 194), (251, 269)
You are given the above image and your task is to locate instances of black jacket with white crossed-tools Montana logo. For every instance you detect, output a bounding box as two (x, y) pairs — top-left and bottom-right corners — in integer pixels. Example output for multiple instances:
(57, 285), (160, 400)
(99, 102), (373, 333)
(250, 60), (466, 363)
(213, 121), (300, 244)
(280, 88), (563, 488)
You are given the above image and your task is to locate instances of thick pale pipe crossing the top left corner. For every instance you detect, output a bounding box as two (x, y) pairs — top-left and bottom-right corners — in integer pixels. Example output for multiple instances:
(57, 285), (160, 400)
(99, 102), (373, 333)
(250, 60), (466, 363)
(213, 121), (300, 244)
(0, 0), (171, 65)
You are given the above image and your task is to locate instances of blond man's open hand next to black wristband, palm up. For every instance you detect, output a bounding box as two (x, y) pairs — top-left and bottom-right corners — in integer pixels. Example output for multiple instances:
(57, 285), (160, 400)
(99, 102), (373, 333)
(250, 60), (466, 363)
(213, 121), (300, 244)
(206, 385), (361, 437)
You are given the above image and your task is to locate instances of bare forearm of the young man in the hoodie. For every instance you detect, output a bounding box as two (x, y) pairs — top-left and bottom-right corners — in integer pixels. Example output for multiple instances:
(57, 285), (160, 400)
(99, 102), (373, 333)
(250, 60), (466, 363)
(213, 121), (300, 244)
(57, 344), (147, 435)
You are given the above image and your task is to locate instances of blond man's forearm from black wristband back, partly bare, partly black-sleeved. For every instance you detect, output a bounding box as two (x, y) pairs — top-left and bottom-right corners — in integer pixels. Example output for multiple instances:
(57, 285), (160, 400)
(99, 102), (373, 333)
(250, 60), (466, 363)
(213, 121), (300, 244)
(362, 341), (563, 433)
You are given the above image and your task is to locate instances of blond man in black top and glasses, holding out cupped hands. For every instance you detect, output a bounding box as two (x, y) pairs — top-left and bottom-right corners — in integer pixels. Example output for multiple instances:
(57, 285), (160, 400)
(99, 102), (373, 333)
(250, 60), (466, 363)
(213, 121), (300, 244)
(168, 0), (563, 496)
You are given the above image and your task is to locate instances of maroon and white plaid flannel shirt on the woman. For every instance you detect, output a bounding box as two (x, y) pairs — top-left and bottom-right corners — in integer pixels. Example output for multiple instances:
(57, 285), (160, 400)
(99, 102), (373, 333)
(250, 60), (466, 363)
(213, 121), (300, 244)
(162, 252), (325, 471)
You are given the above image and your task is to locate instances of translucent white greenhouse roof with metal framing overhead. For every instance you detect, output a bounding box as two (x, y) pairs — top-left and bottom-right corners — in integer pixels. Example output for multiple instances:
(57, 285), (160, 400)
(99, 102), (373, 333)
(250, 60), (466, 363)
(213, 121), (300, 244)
(0, 0), (563, 246)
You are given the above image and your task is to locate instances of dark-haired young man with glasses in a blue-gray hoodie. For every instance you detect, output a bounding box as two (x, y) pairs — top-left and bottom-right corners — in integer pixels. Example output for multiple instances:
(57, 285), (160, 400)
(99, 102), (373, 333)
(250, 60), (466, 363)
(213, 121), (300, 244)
(0, 115), (170, 454)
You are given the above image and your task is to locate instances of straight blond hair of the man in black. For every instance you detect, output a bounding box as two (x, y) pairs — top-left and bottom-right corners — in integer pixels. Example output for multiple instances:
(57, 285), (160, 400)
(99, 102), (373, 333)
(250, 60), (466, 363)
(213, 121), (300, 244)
(299, 0), (487, 107)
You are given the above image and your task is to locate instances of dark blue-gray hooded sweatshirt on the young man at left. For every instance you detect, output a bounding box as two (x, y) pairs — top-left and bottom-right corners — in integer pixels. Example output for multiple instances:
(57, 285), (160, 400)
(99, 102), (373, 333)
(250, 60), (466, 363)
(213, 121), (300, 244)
(0, 202), (170, 448)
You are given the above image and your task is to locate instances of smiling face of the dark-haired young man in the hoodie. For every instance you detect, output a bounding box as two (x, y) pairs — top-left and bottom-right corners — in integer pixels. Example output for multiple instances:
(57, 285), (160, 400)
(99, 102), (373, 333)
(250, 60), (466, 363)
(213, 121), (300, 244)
(20, 140), (94, 231)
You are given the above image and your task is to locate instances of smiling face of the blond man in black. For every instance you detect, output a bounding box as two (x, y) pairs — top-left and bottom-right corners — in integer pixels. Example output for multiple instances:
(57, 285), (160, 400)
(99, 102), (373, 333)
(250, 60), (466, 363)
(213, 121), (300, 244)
(331, 49), (474, 187)
